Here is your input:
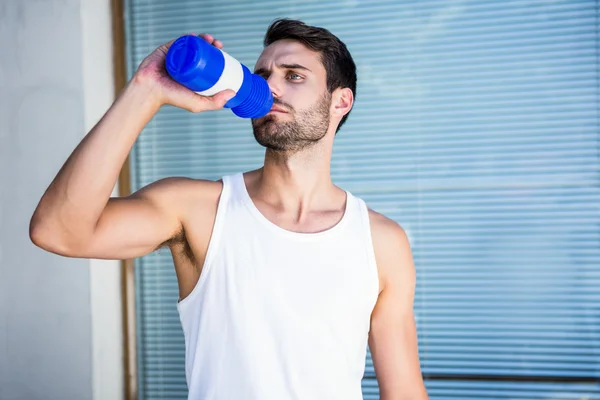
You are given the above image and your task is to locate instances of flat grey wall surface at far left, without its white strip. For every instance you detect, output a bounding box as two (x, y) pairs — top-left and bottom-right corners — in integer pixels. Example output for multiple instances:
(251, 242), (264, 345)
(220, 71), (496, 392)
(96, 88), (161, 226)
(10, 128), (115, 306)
(0, 0), (93, 400)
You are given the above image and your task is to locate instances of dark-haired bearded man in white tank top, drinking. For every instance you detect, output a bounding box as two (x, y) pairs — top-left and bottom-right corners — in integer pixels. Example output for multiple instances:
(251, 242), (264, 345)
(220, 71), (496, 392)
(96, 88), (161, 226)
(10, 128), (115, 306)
(30, 20), (427, 400)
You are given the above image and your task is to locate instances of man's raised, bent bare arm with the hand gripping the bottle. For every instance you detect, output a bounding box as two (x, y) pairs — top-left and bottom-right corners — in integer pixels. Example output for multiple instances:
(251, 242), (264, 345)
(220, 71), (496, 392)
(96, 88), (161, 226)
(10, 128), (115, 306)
(29, 35), (234, 259)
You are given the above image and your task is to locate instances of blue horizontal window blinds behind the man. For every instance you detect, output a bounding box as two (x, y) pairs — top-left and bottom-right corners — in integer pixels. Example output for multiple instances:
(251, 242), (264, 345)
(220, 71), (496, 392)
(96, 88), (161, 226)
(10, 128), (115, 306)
(126, 0), (600, 400)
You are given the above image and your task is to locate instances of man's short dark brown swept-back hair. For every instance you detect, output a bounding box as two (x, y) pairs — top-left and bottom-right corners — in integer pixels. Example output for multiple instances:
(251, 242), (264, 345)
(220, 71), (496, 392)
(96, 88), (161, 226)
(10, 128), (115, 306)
(263, 18), (356, 132)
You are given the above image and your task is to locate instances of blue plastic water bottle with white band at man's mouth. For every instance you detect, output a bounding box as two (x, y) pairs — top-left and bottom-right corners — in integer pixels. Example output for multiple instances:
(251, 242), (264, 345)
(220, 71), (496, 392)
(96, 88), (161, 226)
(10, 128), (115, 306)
(165, 35), (273, 118)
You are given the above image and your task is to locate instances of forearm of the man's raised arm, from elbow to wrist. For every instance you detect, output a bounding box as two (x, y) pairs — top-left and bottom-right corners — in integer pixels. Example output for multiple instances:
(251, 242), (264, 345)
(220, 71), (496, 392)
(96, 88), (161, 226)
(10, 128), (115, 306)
(30, 80), (160, 241)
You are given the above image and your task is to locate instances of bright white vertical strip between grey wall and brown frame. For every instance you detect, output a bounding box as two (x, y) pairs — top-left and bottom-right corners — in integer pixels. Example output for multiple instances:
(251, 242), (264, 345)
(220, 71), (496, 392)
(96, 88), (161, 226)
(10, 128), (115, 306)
(81, 0), (125, 400)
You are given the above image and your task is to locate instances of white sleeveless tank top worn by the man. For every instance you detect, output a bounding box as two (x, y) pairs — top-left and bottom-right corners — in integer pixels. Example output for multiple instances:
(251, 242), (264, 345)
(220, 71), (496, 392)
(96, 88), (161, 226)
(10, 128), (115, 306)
(177, 174), (379, 400)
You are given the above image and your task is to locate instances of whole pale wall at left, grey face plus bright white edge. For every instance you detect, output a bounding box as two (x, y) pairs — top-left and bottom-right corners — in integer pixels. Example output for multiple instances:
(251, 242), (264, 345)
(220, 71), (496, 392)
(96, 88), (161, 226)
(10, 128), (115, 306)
(0, 0), (124, 400)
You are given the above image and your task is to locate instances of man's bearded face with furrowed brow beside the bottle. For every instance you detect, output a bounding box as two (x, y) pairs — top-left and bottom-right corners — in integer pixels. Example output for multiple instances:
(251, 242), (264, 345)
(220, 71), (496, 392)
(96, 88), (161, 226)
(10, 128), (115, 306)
(252, 40), (331, 152)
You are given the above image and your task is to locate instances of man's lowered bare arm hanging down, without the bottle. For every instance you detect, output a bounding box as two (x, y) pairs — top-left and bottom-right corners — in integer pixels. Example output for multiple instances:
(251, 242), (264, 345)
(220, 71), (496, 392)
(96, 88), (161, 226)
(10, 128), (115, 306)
(369, 212), (428, 400)
